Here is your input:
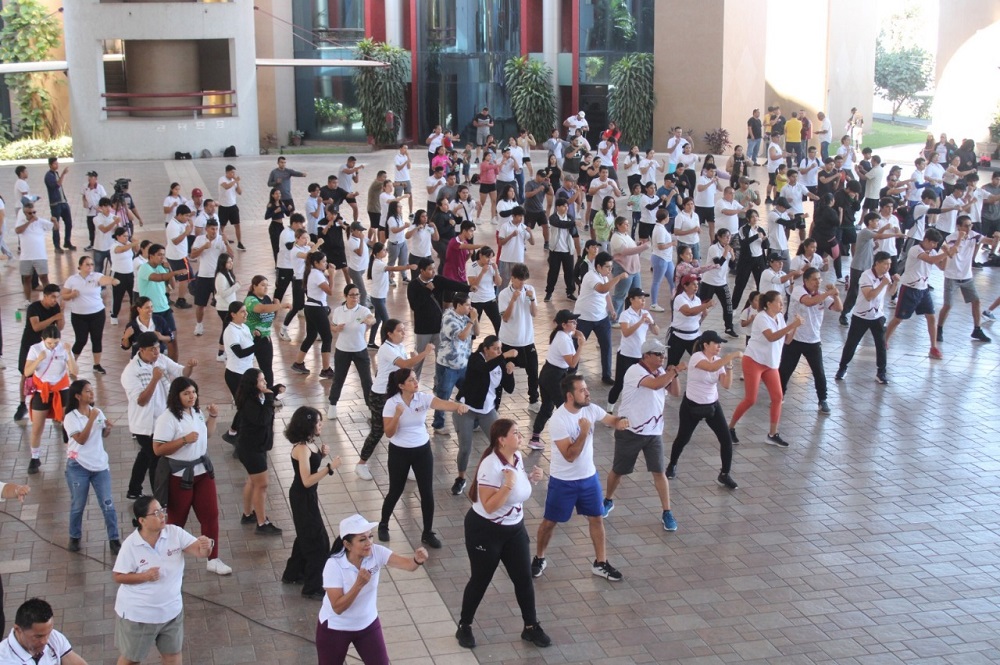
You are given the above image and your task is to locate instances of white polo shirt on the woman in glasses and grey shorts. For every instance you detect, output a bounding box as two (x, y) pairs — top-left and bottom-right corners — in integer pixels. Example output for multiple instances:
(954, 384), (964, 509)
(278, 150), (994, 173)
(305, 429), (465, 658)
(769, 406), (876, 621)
(114, 524), (198, 623)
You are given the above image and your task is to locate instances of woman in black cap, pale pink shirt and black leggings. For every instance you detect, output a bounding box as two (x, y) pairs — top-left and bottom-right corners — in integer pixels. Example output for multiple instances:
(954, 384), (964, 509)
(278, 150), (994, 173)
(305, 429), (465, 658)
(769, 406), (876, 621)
(667, 330), (743, 490)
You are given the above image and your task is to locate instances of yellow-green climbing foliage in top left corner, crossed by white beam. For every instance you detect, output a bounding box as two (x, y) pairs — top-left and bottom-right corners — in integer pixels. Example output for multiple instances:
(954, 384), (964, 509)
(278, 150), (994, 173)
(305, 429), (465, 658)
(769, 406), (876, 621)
(0, 0), (62, 138)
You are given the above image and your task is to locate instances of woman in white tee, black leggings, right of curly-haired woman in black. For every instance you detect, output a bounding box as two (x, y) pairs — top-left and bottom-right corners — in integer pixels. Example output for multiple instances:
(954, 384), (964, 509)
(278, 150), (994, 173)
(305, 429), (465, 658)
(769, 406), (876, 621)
(378, 367), (469, 549)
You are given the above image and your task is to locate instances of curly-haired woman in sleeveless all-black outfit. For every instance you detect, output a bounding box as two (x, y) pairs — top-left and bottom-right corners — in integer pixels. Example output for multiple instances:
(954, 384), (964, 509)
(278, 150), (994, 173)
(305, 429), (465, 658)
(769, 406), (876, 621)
(281, 406), (340, 600)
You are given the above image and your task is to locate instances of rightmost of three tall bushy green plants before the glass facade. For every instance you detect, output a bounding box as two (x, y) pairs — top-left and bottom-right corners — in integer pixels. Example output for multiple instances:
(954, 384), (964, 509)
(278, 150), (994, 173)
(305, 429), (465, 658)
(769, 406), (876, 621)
(608, 53), (656, 147)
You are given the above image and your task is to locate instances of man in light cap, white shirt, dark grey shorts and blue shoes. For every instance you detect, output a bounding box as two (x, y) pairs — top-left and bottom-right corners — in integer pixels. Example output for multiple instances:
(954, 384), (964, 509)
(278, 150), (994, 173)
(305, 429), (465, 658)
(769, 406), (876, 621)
(604, 337), (685, 531)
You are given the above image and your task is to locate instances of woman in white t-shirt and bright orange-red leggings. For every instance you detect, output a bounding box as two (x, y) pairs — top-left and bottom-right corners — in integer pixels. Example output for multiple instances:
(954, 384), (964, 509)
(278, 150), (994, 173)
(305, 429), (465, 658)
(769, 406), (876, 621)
(729, 291), (804, 448)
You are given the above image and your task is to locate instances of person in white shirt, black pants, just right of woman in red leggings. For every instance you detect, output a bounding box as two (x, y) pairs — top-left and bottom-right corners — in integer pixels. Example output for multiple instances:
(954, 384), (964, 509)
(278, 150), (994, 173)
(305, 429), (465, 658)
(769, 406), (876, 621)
(776, 267), (844, 414)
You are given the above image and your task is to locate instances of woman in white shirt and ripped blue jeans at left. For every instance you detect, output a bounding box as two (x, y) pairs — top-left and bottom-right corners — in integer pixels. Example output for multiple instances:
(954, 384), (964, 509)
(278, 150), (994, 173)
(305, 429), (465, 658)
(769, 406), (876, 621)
(63, 379), (122, 556)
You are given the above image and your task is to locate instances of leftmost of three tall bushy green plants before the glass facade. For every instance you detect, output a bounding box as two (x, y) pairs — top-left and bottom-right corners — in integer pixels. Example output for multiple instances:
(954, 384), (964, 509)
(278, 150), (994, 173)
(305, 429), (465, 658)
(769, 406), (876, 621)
(354, 39), (410, 145)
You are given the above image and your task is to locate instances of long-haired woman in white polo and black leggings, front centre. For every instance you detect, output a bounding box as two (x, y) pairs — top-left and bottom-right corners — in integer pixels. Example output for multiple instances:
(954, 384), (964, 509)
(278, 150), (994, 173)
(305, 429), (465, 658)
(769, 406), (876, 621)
(455, 418), (551, 649)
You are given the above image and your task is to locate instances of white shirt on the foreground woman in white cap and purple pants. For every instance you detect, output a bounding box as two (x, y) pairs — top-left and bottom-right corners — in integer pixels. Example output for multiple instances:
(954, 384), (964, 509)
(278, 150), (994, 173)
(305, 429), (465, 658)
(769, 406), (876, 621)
(319, 545), (392, 631)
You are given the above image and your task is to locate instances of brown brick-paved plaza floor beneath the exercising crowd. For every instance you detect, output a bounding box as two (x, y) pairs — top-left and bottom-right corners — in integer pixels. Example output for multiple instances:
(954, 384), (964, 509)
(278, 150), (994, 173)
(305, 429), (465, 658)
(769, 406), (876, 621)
(0, 148), (1000, 665)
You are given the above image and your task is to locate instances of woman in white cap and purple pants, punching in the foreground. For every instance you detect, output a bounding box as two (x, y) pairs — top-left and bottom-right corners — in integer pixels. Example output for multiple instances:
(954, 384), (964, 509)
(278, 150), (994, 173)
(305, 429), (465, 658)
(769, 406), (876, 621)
(316, 515), (427, 665)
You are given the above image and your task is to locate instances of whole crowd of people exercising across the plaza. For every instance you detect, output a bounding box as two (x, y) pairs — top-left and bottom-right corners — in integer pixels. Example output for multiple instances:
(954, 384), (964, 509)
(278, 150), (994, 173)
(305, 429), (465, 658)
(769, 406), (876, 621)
(0, 101), (1000, 663)
